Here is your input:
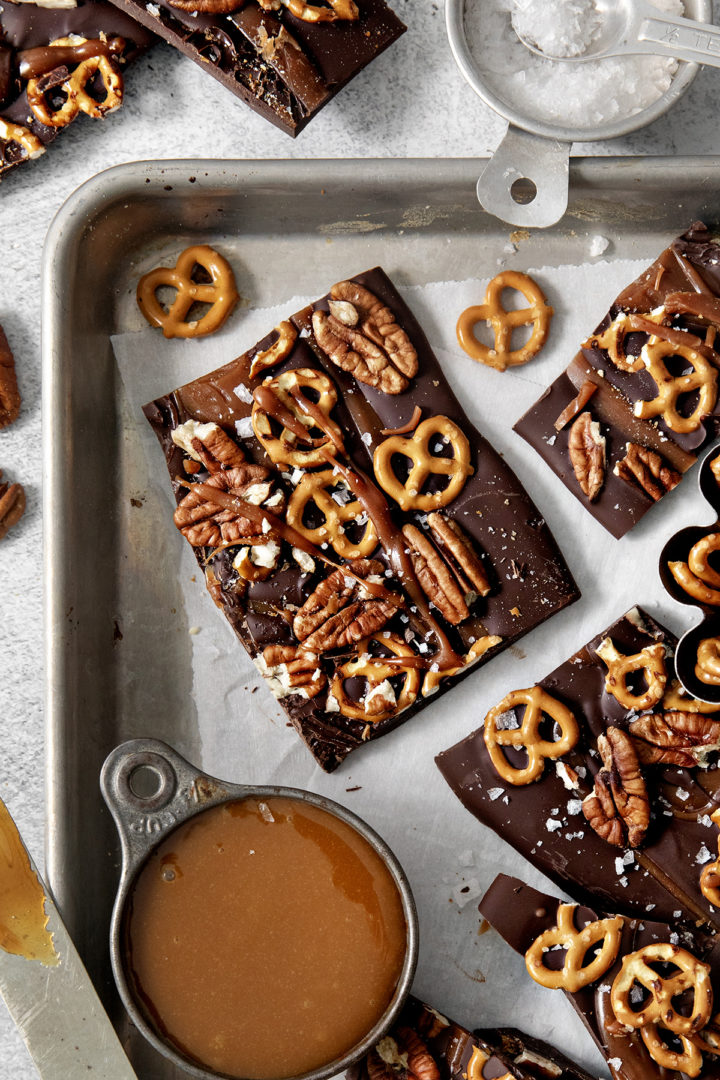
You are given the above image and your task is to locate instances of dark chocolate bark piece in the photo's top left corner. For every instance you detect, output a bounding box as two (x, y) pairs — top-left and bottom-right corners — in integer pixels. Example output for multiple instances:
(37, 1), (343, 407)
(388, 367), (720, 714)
(0, 0), (155, 174)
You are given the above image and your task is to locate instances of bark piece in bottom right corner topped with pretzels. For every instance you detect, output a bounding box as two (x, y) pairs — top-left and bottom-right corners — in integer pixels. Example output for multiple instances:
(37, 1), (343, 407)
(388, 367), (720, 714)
(479, 874), (720, 1080)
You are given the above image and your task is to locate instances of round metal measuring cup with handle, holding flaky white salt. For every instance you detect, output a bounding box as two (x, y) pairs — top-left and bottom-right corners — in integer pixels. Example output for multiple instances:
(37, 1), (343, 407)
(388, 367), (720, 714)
(445, 0), (712, 228)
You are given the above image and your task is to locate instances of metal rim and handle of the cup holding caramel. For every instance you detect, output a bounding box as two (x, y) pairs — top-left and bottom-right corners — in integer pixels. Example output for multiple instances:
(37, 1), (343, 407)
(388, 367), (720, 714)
(100, 739), (418, 1080)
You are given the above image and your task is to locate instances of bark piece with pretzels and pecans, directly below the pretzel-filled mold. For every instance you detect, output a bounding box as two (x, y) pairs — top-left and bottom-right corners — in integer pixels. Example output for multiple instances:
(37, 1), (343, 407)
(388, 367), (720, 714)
(436, 608), (720, 929)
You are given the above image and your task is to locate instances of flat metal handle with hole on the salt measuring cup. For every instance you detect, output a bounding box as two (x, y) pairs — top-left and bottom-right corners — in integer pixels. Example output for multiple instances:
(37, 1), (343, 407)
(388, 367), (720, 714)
(477, 124), (570, 229)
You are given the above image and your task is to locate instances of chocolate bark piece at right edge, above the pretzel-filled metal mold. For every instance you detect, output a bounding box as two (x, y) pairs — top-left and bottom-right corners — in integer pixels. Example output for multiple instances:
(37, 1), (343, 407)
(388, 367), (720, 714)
(514, 222), (720, 538)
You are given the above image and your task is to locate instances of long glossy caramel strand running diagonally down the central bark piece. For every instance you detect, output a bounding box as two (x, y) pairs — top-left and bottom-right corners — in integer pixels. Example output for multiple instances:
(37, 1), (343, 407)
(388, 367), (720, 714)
(254, 383), (464, 671)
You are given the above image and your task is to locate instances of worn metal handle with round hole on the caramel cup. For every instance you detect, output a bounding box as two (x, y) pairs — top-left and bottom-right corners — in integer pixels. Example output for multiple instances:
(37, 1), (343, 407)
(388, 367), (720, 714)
(100, 739), (231, 864)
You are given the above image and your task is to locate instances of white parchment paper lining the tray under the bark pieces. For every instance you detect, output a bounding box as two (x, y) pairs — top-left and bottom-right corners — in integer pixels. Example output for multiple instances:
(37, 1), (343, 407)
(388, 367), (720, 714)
(113, 260), (712, 1077)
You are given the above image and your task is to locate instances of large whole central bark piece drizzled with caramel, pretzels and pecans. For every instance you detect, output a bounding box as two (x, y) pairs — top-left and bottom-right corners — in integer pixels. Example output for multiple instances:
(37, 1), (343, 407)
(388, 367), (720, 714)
(146, 269), (578, 770)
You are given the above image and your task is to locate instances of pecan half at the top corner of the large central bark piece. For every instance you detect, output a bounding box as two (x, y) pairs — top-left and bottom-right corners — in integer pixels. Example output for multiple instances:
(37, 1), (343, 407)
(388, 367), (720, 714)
(312, 281), (418, 394)
